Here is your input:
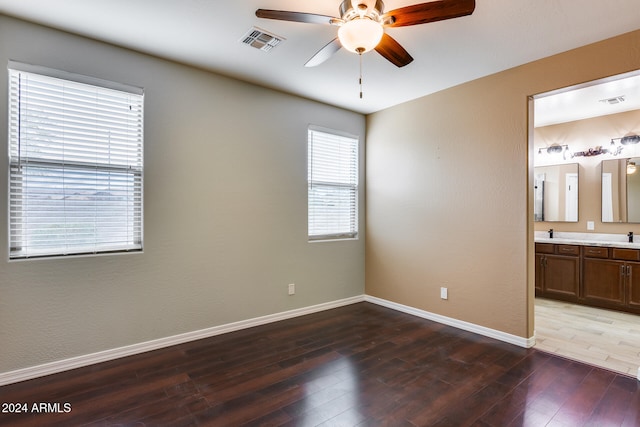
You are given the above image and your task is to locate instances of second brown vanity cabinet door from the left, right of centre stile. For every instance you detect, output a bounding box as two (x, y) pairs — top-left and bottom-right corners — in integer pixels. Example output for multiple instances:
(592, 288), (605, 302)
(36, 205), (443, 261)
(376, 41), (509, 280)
(582, 258), (626, 307)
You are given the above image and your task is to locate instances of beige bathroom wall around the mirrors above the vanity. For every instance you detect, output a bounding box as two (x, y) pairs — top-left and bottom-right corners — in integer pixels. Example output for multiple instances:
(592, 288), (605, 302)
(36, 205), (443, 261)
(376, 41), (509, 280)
(534, 110), (640, 234)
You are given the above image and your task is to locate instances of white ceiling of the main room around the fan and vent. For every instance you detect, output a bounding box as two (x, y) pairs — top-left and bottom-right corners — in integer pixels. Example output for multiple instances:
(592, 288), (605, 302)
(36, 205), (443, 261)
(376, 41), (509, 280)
(0, 0), (640, 114)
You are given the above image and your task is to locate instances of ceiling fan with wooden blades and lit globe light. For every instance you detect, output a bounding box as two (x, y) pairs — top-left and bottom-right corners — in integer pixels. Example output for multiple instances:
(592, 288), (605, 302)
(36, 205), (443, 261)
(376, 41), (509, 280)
(256, 0), (476, 67)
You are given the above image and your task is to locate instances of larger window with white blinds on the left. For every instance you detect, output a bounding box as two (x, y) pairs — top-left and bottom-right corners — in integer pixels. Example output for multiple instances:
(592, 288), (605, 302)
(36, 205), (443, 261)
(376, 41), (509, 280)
(8, 62), (143, 259)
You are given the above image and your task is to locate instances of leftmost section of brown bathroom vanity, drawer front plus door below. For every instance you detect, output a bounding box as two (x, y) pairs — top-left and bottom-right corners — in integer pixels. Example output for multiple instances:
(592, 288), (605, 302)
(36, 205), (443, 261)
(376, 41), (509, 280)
(536, 243), (580, 302)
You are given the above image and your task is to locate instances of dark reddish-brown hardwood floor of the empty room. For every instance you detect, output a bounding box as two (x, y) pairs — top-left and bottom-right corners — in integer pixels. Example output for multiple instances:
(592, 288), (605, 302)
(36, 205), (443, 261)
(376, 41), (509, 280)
(0, 303), (640, 427)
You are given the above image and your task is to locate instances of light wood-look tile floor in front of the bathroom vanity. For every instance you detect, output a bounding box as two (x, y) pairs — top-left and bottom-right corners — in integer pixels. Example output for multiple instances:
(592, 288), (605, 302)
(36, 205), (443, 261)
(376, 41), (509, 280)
(535, 298), (640, 378)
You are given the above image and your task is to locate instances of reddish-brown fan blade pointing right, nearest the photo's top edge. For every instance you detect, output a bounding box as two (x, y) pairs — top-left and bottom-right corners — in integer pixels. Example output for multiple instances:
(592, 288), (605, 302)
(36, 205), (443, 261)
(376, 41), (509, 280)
(383, 0), (476, 27)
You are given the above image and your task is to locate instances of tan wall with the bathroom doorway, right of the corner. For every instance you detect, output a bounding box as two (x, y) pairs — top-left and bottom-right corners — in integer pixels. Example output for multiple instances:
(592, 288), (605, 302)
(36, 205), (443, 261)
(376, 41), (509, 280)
(366, 31), (640, 338)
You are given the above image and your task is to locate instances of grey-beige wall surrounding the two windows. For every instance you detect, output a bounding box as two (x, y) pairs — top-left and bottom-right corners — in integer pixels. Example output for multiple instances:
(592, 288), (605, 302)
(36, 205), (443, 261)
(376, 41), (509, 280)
(0, 15), (365, 373)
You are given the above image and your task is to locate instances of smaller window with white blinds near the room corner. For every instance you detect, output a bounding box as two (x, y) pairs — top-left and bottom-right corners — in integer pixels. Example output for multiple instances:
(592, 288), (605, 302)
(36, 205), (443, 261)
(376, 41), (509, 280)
(308, 128), (358, 240)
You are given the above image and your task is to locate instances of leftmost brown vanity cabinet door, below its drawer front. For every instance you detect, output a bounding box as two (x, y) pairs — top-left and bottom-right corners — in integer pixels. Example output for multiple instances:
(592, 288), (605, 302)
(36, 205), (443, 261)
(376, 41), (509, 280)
(543, 255), (580, 301)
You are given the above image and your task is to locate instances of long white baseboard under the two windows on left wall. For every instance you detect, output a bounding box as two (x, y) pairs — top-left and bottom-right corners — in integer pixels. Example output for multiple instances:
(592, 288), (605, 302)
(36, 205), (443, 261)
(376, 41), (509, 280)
(0, 295), (364, 386)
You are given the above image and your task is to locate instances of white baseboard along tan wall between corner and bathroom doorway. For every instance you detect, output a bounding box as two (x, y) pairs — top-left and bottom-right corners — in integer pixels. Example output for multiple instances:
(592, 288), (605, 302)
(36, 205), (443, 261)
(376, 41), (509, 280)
(364, 295), (535, 348)
